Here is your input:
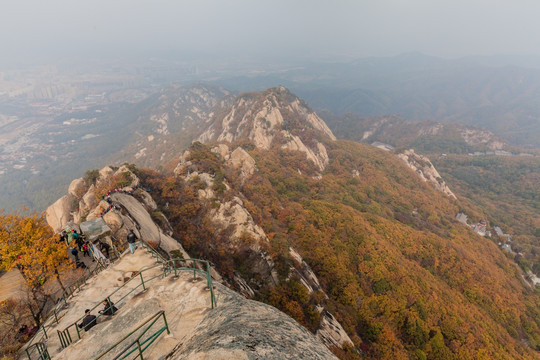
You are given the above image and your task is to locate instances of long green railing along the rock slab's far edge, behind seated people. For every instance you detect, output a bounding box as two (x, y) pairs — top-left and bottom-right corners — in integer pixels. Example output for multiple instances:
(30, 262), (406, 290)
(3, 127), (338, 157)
(57, 249), (217, 348)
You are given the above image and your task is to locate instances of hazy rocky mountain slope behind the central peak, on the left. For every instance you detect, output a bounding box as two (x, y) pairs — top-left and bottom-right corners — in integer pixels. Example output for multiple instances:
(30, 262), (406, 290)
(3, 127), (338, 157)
(0, 83), (229, 211)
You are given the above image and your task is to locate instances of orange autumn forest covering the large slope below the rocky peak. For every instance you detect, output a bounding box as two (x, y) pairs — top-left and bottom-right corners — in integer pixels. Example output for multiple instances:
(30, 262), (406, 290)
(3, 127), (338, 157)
(132, 141), (540, 359)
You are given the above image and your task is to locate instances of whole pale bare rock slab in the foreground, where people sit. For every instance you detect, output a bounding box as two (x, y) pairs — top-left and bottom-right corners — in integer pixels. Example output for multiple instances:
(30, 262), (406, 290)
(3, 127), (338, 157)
(38, 249), (337, 360)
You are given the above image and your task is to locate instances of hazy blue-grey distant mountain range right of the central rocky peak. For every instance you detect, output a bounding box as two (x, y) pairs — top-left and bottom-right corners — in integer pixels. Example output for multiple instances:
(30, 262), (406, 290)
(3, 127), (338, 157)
(215, 53), (540, 148)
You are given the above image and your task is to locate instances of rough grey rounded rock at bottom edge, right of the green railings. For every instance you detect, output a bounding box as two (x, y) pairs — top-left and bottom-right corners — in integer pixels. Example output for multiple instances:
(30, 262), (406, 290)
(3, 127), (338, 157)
(171, 282), (337, 360)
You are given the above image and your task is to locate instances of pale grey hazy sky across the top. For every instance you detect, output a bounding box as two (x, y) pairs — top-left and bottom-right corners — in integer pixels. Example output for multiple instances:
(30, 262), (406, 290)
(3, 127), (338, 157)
(0, 0), (540, 62)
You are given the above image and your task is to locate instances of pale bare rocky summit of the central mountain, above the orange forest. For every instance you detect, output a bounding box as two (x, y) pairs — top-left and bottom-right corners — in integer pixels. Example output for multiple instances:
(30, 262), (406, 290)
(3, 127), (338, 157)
(199, 86), (336, 170)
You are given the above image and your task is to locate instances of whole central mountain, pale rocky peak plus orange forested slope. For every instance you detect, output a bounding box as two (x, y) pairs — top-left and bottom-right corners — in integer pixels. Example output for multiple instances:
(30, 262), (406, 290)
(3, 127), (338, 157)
(39, 88), (540, 360)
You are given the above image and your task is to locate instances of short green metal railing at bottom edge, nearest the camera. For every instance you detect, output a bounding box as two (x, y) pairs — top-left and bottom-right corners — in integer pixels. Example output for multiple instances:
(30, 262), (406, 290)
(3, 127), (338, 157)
(94, 310), (171, 360)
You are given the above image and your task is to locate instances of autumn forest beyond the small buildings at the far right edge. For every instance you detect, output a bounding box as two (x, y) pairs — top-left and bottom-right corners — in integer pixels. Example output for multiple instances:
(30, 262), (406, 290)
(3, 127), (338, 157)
(435, 155), (540, 276)
